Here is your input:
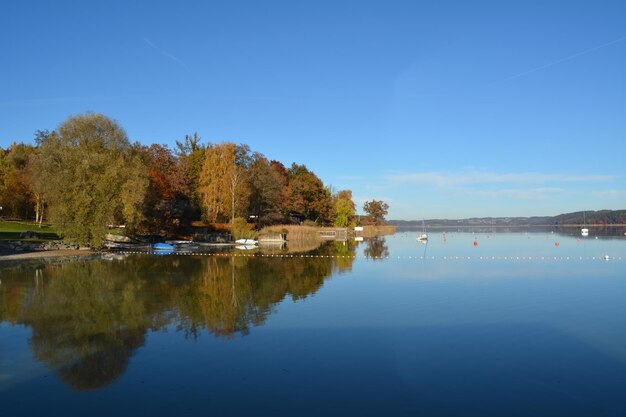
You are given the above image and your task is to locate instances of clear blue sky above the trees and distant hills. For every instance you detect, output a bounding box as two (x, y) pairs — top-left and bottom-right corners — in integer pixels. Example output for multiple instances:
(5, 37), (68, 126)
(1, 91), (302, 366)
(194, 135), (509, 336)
(0, 0), (626, 219)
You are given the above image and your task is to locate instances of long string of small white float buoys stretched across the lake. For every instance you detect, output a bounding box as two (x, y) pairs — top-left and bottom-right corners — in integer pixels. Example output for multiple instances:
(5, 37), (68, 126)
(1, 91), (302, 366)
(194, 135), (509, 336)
(116, 251), (622, 261)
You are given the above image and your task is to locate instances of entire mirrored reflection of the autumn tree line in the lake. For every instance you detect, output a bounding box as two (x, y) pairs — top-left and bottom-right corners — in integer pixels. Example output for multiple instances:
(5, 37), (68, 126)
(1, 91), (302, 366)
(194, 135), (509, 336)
(0, 242), (355, 390)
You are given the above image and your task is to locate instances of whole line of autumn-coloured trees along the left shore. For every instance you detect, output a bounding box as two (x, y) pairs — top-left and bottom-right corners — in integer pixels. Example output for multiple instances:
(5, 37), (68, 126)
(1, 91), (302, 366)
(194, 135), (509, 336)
(0, 113), (388, 246)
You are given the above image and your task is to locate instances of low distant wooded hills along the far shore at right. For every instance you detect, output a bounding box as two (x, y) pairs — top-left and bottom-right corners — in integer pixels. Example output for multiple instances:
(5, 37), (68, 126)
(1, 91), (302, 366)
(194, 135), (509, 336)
(388, 210), (626, 227)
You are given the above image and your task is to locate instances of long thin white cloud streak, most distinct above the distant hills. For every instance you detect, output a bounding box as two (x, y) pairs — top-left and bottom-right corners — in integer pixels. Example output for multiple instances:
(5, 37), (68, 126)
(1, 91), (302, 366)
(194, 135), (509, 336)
(386, 172), (613, 187)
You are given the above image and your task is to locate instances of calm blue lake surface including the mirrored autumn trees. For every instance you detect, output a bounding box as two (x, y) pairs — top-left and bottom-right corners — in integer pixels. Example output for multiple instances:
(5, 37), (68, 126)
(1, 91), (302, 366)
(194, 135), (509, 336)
(0, 232), (626, 417)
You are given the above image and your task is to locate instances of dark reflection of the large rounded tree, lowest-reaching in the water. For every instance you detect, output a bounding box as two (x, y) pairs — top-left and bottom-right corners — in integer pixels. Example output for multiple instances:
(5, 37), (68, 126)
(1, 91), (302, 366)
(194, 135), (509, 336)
(23, 261), (158, 389)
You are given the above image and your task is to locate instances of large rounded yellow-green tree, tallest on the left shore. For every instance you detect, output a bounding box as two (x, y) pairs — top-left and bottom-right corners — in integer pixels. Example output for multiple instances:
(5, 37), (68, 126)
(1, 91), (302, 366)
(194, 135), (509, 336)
(33, 113), (148, 246)
